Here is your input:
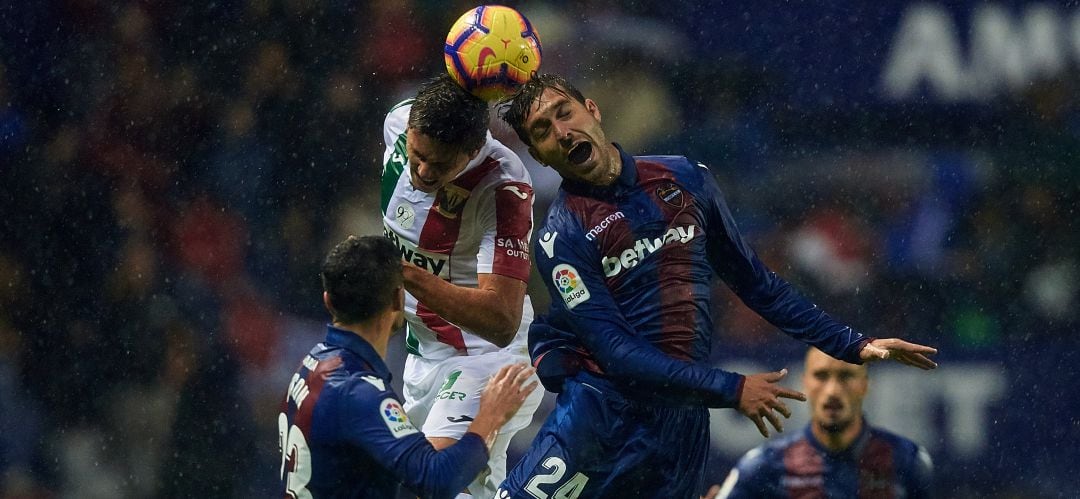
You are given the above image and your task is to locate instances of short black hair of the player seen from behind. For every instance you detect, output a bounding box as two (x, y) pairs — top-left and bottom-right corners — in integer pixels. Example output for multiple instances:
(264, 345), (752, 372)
(322, 235), (404, 324)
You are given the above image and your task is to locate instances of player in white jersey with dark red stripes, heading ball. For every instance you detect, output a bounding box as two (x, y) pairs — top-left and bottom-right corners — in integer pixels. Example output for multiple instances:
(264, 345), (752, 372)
(382, 75), (543, 497)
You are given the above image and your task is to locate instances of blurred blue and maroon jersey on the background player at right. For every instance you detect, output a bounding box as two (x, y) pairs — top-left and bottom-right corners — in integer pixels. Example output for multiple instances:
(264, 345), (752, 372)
(720, 423), (933, 499)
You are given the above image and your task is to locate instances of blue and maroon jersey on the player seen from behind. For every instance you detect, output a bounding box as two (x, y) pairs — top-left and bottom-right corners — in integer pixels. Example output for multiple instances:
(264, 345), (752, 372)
(278, 326), (487, 498)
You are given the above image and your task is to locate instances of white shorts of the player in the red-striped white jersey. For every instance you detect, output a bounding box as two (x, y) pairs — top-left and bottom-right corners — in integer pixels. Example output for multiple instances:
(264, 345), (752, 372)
(402, 350), (543, 498)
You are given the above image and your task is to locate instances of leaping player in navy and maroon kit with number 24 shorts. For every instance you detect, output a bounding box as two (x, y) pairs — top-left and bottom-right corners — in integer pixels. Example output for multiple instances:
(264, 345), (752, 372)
(496, 75), (936, 499)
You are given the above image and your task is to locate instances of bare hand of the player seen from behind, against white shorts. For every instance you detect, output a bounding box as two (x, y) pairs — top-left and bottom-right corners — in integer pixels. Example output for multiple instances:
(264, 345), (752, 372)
(469, 362), (537, 450)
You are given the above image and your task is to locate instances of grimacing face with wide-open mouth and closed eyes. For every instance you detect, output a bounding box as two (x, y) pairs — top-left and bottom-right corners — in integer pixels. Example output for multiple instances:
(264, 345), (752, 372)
(525, 89), (622, 186)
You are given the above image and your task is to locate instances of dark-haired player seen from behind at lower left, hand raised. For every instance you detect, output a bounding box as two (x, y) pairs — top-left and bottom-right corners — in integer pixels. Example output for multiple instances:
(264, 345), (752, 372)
(278, 237), (536, 498)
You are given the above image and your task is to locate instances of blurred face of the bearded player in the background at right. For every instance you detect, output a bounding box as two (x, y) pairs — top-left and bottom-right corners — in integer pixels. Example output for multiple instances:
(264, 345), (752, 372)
(802, 350), (869, 433)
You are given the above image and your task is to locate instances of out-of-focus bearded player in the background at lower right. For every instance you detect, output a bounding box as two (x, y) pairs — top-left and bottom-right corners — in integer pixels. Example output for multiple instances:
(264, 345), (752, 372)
(705, 348), (933, 499)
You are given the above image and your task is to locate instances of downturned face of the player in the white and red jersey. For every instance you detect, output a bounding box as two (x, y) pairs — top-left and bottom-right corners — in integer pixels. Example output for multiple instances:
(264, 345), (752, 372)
(405, 127), (474, 192)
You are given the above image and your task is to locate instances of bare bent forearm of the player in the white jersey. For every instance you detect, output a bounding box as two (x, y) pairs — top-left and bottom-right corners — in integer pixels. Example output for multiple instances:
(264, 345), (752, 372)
(405, 266), (522, 347)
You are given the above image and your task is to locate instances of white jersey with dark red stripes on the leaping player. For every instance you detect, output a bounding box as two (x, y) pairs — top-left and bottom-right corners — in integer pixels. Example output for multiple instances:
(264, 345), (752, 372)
(381, 100), (534, 360)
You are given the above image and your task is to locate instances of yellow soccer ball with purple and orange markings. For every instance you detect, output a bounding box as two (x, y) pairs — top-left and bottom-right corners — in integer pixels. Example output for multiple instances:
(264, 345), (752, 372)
(443, 5), (541, 102)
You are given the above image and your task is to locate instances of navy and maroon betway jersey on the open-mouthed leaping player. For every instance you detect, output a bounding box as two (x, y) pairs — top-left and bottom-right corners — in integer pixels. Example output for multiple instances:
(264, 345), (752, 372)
(529, 144), (867, 407)
